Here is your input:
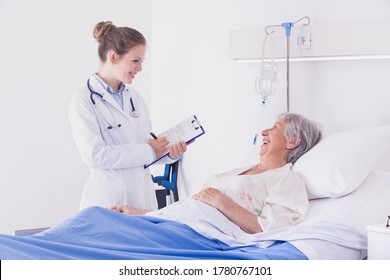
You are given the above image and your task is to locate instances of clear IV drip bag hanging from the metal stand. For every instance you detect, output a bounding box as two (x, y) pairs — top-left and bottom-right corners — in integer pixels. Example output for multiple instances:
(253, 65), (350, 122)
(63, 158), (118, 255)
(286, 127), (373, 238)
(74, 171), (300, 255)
(255, 61), (277, 96)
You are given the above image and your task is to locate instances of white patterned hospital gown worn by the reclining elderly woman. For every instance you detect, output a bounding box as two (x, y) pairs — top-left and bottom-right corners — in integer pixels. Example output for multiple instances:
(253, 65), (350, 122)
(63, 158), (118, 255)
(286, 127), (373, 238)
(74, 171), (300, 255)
(204, 163), (309, 231)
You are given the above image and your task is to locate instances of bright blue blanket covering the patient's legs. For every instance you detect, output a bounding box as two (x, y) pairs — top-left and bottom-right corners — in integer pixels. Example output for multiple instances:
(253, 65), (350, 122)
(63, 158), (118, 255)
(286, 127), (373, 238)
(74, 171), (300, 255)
(0, 207), (307, 260)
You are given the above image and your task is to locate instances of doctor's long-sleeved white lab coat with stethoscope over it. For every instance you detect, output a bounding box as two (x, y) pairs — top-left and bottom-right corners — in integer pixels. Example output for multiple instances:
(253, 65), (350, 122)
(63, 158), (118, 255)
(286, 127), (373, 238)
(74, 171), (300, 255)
(69, 76), (173, 210)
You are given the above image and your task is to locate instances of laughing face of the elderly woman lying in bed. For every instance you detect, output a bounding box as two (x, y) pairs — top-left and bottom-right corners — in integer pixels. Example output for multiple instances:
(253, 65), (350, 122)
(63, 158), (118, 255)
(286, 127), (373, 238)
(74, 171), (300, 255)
(260, 119), (288, 159)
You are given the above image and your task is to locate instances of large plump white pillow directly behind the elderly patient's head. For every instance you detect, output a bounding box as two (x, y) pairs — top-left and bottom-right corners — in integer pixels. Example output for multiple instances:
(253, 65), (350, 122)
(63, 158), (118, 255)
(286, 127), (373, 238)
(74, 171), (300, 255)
(293, 126), (390, 199)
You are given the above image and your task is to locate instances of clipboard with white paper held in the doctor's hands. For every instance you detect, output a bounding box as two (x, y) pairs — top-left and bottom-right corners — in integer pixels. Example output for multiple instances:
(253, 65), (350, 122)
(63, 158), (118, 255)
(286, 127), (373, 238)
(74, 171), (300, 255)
(144, 115), (205, 168)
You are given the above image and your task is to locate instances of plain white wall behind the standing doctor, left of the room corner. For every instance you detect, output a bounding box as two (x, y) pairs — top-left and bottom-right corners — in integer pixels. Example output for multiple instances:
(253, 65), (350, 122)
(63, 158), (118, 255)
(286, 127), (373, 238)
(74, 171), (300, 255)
(0, 0), (152, 233)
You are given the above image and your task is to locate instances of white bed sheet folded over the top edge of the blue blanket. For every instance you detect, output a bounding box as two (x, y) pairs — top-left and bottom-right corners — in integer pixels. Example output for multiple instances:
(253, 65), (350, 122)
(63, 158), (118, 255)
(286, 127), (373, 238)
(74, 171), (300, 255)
(147, 199), (367, 260)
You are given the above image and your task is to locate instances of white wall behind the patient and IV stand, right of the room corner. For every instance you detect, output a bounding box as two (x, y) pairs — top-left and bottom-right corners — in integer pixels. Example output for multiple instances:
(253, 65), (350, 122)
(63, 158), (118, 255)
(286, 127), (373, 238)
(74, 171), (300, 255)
(152, 0), (390, 198)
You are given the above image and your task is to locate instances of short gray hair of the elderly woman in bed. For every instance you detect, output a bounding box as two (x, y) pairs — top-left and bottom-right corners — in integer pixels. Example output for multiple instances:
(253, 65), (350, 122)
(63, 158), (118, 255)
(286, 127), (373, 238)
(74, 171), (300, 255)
(279, 113), (322, 164)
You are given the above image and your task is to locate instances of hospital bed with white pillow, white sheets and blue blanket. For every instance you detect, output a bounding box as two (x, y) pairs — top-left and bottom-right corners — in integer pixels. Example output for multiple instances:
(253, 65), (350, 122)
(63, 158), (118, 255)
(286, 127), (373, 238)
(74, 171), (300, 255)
(0, 126), (390, 260)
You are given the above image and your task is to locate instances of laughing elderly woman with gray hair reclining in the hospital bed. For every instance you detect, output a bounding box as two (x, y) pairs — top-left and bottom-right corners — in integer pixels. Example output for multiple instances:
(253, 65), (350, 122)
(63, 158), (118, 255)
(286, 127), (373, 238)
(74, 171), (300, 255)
(111, 113), (322, 236)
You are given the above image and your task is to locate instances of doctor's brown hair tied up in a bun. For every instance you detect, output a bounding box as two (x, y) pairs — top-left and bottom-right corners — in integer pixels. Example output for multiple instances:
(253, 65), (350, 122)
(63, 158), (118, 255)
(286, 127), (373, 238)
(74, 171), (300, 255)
(93, 21), (146, 62)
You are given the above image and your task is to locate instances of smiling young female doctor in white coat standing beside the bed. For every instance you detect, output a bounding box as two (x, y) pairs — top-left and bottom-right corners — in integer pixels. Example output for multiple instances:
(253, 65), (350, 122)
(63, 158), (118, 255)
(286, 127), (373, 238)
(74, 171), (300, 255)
(69, 21), (187, 210)
